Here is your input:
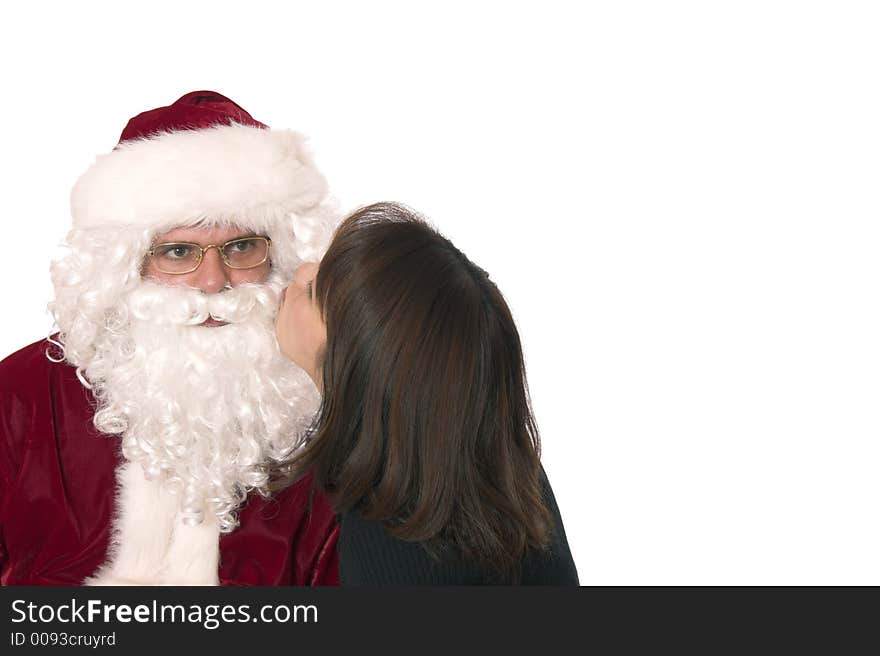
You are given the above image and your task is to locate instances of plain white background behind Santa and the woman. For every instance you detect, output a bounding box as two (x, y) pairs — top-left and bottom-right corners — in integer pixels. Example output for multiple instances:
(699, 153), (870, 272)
(0, 1), (880, 585)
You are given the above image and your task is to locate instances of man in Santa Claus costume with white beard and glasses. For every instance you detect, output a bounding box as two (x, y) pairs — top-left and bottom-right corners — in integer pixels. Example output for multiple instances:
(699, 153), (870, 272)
(0, 91), (338, 585)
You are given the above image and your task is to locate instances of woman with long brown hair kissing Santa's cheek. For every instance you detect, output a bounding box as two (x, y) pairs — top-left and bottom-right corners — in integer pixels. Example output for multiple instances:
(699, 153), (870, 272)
(275, 203), (578, 585)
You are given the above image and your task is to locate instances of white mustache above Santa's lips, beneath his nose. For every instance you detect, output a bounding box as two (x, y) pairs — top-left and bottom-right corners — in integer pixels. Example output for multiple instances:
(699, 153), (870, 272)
(126, 279), (281, 326)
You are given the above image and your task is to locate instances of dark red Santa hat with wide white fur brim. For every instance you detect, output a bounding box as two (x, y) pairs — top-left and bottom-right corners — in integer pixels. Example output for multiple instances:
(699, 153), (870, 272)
(71, 91), (327, 238)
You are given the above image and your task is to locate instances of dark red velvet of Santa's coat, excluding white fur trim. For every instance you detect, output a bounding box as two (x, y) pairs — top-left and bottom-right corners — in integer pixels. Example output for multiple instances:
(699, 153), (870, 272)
(0, 341), (339, 585)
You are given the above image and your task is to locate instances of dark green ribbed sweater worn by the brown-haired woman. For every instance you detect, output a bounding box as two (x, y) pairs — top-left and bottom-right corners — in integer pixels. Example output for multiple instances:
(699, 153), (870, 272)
(339, 478), (578, 585)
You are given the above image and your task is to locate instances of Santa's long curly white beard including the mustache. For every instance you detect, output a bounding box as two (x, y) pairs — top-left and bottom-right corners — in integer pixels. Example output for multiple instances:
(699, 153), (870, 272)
(94, 282), (318, 532)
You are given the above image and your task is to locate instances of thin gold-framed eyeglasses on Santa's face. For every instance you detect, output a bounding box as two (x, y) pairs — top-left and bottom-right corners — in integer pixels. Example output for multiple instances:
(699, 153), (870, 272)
(147, 237), (272, 275)
